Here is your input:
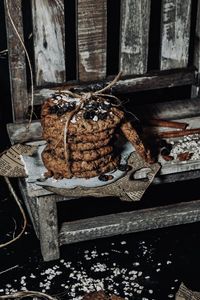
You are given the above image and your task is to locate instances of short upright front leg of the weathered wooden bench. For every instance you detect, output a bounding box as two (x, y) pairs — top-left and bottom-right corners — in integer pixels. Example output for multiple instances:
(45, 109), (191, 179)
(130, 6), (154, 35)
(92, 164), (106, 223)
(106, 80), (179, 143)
(37, 195), (60, 261)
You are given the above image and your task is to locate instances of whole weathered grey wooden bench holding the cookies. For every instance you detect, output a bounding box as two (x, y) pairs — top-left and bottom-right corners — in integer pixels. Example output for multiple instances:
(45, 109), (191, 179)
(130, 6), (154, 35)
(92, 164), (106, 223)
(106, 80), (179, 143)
(4, 0), (200, 261)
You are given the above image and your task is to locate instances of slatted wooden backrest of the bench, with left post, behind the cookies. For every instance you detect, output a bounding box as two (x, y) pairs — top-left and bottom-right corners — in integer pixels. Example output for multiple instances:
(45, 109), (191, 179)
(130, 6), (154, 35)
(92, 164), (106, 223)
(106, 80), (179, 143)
(4, 0), (200, 121)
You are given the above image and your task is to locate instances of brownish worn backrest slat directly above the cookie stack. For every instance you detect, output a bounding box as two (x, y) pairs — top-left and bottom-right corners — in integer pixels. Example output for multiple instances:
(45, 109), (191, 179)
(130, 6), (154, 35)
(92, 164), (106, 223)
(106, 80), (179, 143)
(77, 0), (107, 81)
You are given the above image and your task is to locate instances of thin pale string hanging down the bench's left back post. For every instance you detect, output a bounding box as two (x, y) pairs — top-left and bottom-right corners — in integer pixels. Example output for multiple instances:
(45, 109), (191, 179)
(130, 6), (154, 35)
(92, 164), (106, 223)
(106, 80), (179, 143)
(5, 0), (34, 128)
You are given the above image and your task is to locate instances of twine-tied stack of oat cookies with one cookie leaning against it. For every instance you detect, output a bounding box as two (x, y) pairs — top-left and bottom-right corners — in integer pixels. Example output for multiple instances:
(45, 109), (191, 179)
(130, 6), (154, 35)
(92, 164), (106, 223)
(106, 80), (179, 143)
(41, 93), (152, 179)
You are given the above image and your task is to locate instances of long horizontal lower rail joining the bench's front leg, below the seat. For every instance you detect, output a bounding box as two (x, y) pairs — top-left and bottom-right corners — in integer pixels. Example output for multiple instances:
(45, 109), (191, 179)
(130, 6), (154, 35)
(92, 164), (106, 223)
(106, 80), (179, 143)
(59, 200), (200, 244)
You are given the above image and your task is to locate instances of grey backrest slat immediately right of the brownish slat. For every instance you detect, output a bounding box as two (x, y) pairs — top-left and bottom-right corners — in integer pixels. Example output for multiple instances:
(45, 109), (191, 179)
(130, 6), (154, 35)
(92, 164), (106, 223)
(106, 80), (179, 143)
(119, 0), (151, 75)
